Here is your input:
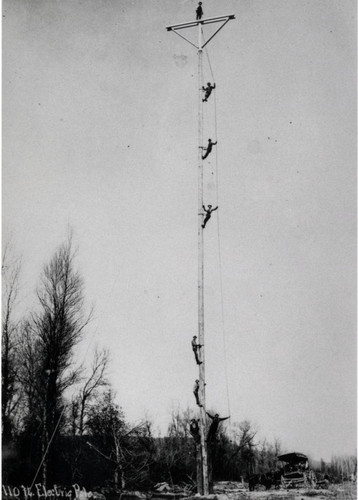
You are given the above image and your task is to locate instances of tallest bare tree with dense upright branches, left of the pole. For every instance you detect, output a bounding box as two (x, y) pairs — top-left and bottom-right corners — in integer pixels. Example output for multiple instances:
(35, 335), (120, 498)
(30, 238), (90, 485)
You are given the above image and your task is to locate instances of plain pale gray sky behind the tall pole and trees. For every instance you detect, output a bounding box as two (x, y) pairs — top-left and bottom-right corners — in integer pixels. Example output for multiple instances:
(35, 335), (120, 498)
(3, 0), (356, 459)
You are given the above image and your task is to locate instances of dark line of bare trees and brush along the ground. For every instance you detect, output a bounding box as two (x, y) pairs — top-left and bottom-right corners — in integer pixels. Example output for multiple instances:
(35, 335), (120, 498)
(1, 237), (356, 492)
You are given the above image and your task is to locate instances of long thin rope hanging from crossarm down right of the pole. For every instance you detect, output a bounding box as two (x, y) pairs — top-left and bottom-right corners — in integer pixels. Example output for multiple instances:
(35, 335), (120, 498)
(205, 47), (231, 434)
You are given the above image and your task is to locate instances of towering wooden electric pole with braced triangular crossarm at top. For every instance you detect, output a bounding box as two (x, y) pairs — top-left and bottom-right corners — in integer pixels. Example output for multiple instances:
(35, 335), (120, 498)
(167, 9), (235, 495)
